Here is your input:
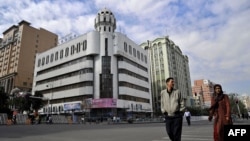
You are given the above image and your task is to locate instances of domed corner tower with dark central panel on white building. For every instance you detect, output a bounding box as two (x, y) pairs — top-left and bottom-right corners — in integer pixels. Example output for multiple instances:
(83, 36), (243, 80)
(94, 8), (117, 98)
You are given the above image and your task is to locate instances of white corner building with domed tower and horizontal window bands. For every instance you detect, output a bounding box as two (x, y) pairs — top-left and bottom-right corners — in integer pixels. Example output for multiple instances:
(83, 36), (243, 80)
(33, 8), (152, 117)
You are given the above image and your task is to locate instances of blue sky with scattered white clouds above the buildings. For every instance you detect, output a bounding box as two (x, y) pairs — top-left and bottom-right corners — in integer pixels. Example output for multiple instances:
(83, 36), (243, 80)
(0, 0), (250, 96)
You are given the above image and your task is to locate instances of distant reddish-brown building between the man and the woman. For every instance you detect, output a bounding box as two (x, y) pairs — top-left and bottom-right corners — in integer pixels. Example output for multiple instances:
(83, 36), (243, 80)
(192, 79), (215, 107)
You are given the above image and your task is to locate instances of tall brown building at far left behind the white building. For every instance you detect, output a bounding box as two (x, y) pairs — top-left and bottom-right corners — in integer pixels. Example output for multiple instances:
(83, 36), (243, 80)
(0, 20), (58, 93)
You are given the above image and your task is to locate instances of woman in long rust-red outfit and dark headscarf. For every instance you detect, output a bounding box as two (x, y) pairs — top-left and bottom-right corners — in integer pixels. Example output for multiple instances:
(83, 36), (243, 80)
(208, 84), (232, 141)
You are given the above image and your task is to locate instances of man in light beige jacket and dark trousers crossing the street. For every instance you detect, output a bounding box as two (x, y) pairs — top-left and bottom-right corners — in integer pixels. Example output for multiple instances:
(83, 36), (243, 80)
(161, 77), (185, 141)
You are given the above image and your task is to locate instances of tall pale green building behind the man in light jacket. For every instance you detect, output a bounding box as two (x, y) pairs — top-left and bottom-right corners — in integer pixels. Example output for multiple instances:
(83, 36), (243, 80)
(141, 37), (192, 113)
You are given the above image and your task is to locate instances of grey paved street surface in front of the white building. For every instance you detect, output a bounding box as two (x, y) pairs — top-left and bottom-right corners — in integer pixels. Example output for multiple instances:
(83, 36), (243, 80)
(0, 120), (250, 141)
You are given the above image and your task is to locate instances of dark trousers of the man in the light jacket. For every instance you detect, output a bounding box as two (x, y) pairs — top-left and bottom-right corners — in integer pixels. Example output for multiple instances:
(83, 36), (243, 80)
(165, 116), (183, 141)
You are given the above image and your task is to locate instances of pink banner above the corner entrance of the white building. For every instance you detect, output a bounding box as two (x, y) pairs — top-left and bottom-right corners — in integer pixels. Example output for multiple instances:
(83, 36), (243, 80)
(91, 98), (117, 108)
